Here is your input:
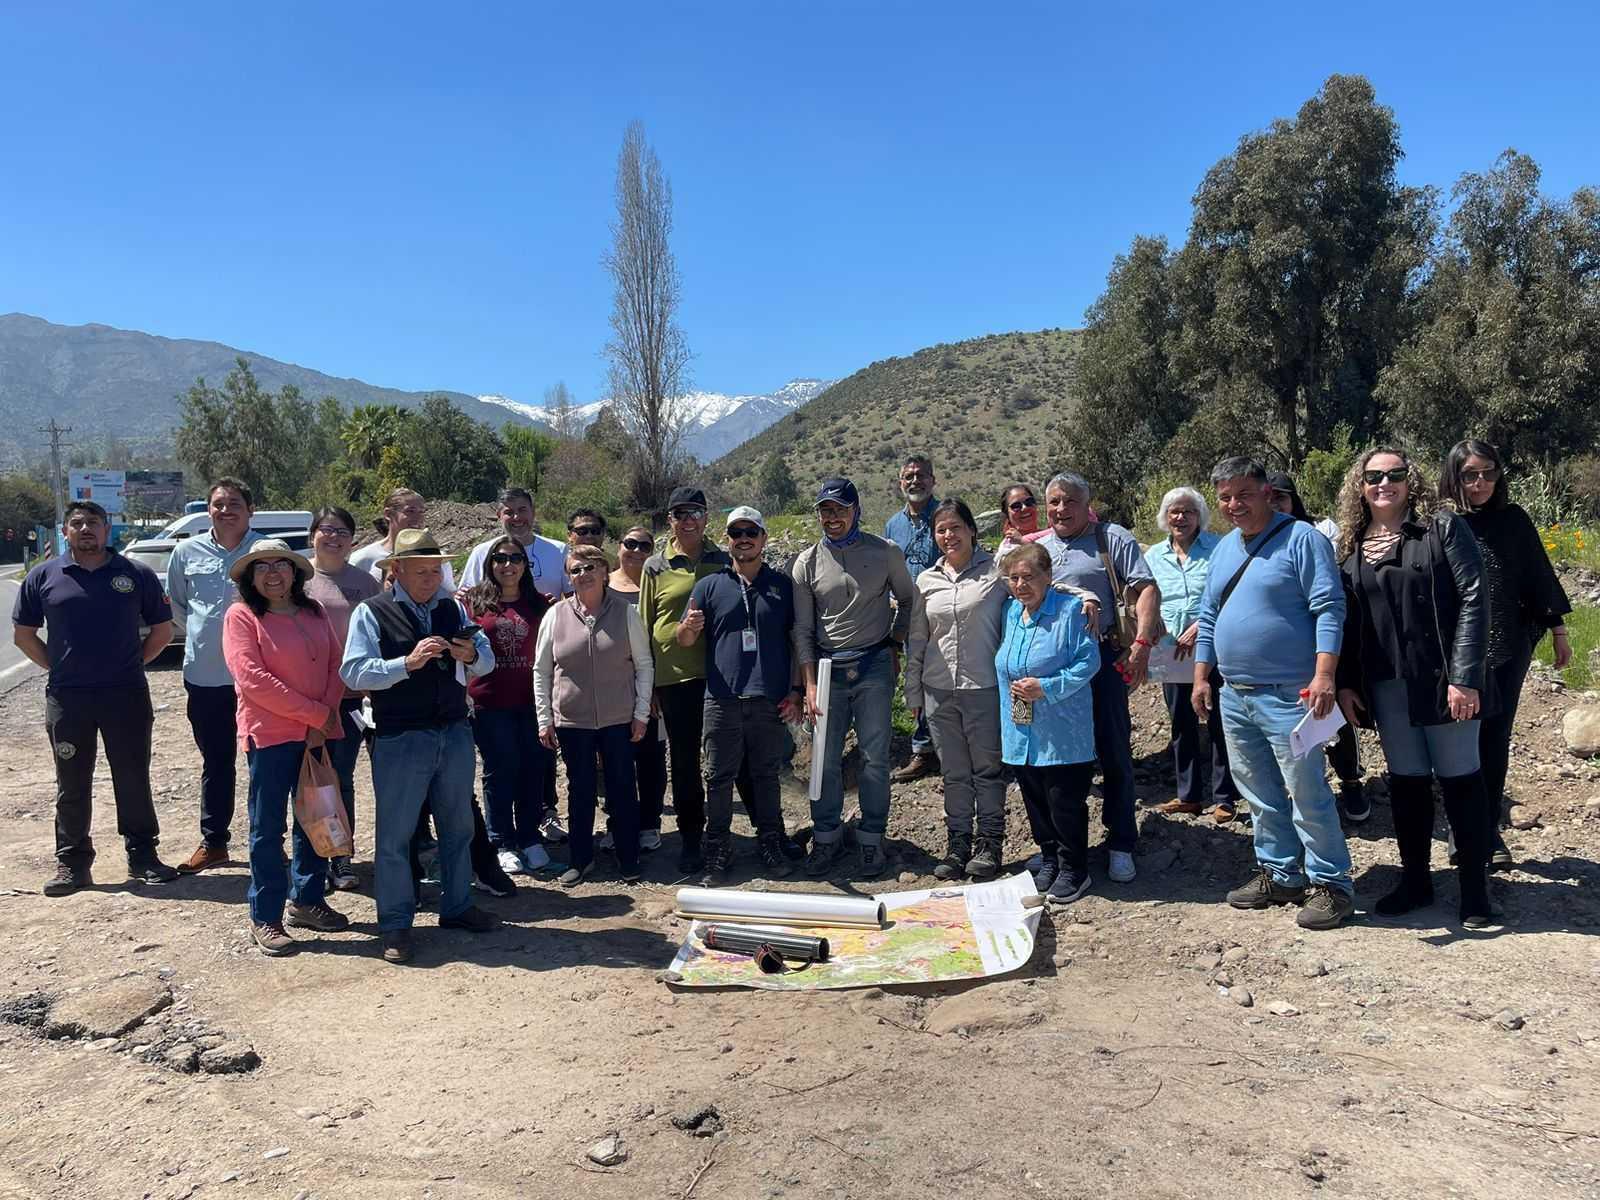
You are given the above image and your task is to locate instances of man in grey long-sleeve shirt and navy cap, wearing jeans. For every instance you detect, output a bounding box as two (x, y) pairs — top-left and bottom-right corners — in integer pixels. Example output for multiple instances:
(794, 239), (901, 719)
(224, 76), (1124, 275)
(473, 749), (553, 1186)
(790, 478), (912, 880)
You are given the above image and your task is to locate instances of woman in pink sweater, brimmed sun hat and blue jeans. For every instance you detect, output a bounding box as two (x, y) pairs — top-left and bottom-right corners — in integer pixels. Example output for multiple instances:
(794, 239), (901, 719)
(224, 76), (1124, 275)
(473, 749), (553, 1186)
(222, 538), (349, 955)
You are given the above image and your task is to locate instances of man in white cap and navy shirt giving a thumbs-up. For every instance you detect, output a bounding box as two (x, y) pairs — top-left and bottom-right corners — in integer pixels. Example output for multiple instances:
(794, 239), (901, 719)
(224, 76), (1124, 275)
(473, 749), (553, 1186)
(677, 506), (805, 888)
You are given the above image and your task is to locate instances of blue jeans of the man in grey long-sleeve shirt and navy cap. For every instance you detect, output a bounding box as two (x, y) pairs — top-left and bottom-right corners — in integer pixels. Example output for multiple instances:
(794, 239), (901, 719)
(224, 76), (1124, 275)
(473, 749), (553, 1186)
(811, 650), (894, 845)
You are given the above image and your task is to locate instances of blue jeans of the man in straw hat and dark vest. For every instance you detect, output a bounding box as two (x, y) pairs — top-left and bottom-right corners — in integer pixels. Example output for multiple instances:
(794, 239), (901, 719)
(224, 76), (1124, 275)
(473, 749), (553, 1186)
(373, 720), (477, 933)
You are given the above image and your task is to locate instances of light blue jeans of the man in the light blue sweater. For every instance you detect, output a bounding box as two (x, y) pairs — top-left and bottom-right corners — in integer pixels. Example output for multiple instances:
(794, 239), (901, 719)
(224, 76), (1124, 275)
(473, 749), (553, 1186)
(1218, 683), (1355, 896)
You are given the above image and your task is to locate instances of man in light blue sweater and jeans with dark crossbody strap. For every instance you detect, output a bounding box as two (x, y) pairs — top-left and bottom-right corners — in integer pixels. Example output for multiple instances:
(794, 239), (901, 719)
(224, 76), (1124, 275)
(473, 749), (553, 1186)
(1194, 458), (1355, 930)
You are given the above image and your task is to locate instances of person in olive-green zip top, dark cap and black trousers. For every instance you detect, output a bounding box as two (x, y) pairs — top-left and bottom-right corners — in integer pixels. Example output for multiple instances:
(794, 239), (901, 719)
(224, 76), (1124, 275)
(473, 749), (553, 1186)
(638, 488), (733, 875)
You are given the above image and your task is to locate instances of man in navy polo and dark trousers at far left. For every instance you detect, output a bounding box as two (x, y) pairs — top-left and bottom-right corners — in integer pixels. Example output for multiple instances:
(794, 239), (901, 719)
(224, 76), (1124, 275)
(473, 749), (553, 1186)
(11, 501), (178, 896)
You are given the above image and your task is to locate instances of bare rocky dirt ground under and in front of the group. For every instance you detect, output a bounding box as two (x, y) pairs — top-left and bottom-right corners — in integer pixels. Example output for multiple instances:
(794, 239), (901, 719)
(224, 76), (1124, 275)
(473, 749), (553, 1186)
(0, 659), (1600, 1200)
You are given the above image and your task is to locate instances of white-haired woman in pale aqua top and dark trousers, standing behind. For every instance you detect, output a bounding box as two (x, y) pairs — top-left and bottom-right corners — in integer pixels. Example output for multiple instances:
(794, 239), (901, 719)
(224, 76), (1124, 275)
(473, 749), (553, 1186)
(1144, 488), (1238, 826)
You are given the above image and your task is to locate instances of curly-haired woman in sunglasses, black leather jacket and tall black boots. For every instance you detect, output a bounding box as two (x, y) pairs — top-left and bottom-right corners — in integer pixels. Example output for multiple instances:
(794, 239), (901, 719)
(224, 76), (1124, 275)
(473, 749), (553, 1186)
(1338, 448), (1494, 928)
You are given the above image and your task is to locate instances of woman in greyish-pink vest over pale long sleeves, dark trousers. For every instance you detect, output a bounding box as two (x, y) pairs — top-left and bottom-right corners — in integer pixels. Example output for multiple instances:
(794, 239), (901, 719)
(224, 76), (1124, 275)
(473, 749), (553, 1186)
(533, 546), (656, 888)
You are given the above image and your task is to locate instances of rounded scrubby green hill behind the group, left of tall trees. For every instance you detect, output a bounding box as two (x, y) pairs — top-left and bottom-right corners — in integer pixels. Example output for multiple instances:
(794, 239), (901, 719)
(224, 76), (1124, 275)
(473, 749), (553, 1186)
(706, 330), (1080, 526)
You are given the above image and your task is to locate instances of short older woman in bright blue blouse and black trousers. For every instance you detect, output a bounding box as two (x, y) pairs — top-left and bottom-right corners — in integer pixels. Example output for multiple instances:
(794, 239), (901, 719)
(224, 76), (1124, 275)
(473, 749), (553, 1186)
(995, 544), (1099, 904)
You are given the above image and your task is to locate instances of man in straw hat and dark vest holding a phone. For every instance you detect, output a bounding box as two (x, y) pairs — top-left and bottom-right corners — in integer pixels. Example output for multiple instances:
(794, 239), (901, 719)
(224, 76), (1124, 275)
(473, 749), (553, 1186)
(339, 530), (499, 963)
